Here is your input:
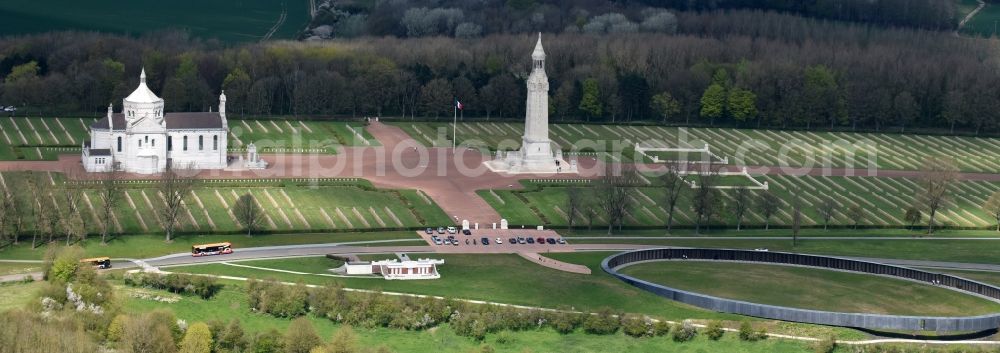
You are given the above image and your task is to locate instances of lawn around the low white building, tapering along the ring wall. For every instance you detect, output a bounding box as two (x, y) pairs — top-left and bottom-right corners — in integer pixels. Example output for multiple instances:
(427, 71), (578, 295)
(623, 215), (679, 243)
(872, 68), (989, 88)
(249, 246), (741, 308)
(170, 253), (862, 338)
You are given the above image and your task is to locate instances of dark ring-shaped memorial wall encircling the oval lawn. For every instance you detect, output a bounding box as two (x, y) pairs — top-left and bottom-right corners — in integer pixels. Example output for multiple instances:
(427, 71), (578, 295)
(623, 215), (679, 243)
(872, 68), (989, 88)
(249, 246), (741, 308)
(601, 248), (1000, 332)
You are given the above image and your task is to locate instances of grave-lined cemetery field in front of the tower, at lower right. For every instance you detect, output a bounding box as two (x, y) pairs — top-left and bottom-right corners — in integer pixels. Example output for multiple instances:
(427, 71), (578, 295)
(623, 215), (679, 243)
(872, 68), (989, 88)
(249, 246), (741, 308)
(479, 176), (1000, 229)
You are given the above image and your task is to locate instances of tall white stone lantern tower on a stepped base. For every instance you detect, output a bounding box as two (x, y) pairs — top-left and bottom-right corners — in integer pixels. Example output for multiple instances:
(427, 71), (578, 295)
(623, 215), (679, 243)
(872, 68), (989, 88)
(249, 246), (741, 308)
(486, 33), (577, 174)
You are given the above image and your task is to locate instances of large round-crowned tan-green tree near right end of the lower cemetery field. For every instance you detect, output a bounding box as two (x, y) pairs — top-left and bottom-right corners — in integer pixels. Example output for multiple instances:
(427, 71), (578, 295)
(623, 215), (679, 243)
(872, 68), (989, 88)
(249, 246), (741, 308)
(919, 157), (958, 234)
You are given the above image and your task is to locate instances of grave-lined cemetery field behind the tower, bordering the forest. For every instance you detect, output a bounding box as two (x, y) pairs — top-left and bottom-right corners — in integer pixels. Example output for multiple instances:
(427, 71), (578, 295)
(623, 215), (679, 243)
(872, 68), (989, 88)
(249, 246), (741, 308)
(394, 121), (1000, 173)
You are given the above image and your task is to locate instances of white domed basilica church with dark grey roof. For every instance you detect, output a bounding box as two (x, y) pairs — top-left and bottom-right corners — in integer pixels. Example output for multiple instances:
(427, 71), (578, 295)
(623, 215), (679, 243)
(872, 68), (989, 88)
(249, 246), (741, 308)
(82, 69), (229, 174)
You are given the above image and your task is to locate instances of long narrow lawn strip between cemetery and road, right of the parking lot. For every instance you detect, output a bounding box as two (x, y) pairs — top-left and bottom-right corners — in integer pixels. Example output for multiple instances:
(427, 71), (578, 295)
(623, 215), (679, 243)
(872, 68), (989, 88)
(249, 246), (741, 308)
(571, 237), (1000, 264)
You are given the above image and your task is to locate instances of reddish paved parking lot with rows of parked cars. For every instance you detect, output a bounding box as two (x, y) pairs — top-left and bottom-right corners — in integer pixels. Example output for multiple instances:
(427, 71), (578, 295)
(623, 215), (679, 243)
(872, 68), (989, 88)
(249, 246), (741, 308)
(417, 228), (572, 253)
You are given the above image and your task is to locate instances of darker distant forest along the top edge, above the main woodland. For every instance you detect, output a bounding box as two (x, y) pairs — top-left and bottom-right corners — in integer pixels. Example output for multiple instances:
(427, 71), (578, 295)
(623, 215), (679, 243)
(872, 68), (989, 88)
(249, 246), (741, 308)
(303, 0), (955, 39)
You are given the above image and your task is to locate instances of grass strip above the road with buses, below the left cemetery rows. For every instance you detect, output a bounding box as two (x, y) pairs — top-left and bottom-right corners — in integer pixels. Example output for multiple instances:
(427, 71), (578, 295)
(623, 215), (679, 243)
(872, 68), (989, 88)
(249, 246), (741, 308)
(0, 231), (422, 260)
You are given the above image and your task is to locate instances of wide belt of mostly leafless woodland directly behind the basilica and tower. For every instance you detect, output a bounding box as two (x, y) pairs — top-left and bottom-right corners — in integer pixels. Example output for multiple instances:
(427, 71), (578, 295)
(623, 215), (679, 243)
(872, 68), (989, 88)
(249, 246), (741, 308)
(0, 10), (1000, 134)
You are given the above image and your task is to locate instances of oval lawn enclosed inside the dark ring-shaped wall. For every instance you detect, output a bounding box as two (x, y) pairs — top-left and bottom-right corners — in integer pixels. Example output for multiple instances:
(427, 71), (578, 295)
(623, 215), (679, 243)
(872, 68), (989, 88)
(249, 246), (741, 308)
(621, 261), (1000, 316)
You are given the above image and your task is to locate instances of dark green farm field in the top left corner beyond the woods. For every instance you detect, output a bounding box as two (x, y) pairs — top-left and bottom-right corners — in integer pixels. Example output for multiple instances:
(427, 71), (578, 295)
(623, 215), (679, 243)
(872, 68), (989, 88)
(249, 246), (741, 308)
(0, 0), (309, 42)
